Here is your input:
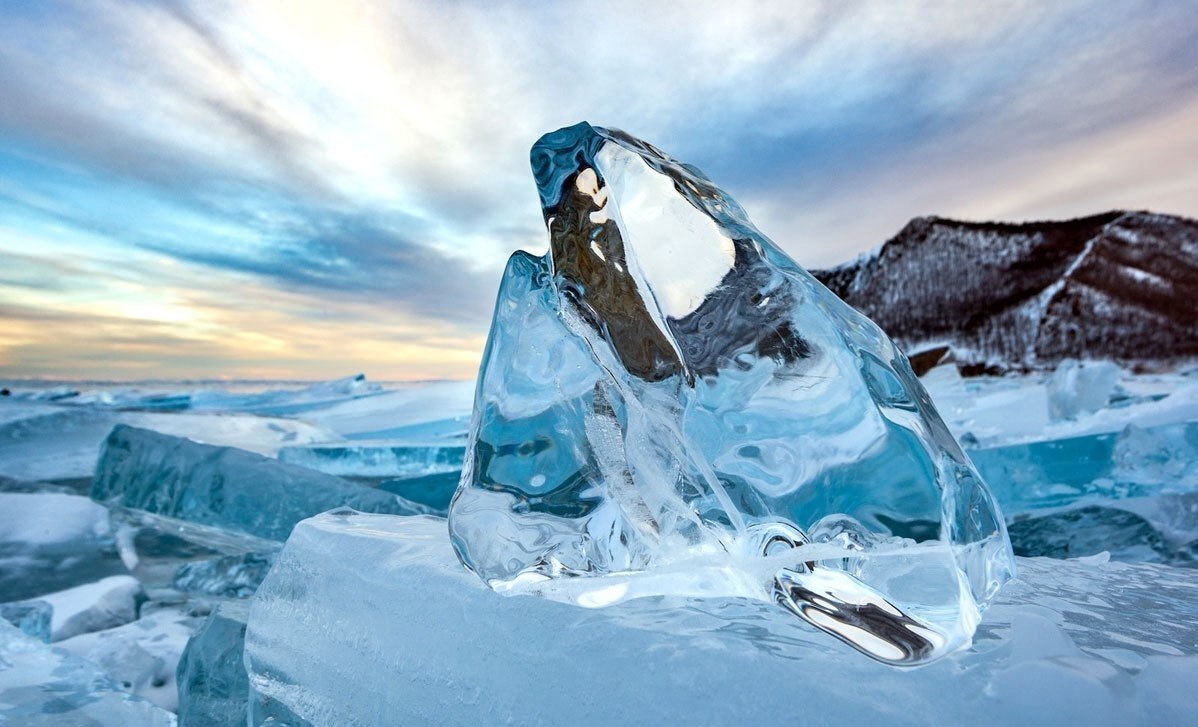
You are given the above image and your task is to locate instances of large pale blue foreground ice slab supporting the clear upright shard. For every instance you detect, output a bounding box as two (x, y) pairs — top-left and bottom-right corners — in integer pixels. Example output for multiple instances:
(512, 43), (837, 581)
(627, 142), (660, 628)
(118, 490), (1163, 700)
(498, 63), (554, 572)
(246, 513), (1198, 727)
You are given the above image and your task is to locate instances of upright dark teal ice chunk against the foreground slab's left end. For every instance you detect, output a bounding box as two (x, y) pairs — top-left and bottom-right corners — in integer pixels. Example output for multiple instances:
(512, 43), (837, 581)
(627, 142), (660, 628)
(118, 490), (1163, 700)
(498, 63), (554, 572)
(177, 602), (249, 727)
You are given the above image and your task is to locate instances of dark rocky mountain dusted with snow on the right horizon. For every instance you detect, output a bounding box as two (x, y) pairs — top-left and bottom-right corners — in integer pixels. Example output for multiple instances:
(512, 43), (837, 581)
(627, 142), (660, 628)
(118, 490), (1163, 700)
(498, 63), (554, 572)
(812, 211), (1198, 372)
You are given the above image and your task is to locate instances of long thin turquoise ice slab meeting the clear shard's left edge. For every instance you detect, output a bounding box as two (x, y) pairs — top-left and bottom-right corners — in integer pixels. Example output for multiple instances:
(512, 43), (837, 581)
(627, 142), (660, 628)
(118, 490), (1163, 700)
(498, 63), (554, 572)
(279, 440), (466, 478)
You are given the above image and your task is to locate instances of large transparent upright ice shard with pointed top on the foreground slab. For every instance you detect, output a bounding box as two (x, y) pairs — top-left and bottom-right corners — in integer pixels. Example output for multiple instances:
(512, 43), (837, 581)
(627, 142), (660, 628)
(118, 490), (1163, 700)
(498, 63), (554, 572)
(449, 123), (1014, 664)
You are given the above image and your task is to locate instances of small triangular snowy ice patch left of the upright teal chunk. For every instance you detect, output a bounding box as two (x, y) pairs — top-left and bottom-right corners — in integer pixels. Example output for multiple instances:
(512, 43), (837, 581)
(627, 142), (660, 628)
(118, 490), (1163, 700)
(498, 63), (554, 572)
(56, 610), (200, 711)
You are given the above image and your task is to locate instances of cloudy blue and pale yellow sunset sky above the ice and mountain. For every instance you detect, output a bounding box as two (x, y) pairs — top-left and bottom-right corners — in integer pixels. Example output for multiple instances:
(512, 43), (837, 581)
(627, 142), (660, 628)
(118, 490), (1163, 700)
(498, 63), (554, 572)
(0, 0), (1198, 381)
